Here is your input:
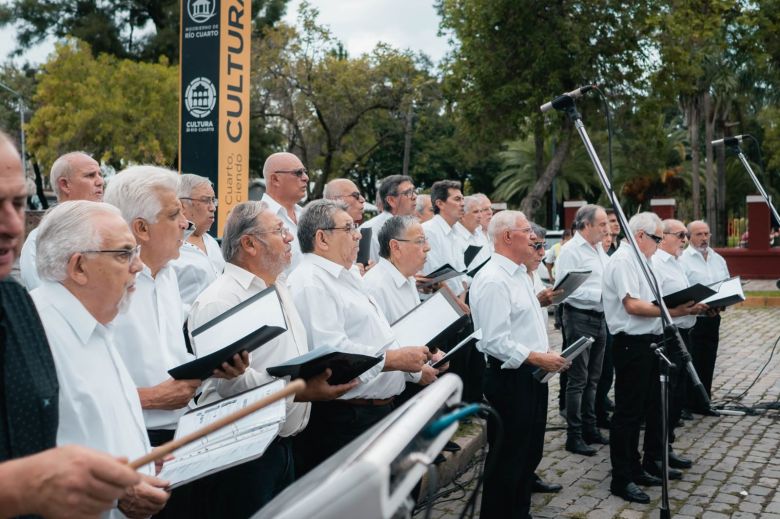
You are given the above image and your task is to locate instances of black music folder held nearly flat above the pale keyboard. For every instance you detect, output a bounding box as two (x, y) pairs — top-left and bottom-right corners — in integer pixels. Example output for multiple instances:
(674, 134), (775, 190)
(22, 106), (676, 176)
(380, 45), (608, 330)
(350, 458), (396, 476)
(266, 346), (382, 385)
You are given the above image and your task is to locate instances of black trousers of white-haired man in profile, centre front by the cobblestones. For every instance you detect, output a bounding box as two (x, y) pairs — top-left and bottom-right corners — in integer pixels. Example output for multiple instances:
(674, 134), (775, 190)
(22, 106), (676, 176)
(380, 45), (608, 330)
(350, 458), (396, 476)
(480, 359), (547, 519)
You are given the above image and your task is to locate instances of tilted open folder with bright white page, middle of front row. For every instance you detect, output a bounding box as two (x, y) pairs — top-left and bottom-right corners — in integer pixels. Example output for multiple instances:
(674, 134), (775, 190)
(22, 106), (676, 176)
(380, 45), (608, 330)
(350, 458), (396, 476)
(391, 290), (469, 350)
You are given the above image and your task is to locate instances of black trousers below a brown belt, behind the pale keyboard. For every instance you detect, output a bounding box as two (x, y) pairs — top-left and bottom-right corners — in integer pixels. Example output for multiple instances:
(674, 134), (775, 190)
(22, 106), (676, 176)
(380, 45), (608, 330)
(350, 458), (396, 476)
(293, 400), (395, 477)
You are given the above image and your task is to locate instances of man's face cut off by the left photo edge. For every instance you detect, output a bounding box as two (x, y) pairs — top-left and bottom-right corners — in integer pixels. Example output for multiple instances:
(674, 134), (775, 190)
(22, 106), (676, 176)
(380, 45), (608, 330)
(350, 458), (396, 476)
(0, 132), (27, 279)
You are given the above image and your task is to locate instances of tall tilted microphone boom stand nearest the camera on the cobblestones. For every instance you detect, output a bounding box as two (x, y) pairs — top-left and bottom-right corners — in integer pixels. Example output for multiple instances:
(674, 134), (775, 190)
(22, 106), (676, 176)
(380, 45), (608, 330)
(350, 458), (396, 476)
(554, 96), (710, 519)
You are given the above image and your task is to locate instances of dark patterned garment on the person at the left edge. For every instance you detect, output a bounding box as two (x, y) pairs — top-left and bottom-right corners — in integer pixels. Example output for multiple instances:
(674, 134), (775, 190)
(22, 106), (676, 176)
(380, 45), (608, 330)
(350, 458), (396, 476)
(0, 279), (59, 462)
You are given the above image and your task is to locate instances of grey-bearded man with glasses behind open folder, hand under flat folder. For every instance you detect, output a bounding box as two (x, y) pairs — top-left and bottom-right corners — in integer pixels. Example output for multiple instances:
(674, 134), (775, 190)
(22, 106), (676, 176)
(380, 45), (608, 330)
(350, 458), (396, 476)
(189, 202), (357, 517)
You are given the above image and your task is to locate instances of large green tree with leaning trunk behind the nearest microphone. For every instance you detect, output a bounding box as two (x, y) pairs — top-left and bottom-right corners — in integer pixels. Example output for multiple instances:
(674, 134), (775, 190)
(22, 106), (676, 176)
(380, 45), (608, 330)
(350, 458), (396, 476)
(437, 0), (652, 221)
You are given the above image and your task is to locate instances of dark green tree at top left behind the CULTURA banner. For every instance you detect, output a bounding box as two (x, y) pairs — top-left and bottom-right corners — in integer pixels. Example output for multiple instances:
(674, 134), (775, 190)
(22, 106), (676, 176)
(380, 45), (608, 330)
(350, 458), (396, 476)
(0, 0), (288, 63)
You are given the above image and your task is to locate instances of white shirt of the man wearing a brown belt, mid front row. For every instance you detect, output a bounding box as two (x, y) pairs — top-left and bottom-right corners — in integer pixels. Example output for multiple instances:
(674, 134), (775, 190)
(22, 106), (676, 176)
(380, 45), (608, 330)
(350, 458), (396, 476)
(288, 253), (405, 399)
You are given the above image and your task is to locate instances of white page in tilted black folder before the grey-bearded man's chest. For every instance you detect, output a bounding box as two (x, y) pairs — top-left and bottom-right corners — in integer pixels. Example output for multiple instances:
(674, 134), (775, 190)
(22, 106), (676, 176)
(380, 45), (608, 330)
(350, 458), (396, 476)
(192, 290), (287, 357)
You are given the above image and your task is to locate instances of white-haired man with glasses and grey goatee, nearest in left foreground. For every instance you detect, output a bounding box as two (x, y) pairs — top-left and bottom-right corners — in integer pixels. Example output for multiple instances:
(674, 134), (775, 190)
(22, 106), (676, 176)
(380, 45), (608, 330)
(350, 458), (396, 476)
(31, 201), (169, 518)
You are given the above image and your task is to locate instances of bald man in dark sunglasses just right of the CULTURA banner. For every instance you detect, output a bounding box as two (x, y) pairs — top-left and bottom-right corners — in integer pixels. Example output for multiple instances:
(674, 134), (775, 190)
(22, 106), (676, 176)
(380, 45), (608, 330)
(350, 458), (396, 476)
(261, 152), (309, 274)
